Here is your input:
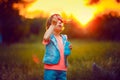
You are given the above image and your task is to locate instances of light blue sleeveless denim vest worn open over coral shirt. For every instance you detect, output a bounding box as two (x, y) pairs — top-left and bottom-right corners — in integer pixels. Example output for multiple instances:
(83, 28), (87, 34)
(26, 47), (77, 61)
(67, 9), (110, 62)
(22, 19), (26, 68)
(43, 34), (71, 66)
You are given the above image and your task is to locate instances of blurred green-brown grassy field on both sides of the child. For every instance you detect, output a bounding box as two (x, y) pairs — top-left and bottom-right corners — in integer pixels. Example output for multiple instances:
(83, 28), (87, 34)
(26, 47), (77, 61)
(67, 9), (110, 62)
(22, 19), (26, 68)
(0, 40), (120, 80)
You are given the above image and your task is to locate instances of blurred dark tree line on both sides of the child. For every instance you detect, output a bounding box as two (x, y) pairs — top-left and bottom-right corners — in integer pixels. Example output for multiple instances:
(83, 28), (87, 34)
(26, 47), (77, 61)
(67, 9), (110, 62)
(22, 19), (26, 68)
(0, 0), (120, 43)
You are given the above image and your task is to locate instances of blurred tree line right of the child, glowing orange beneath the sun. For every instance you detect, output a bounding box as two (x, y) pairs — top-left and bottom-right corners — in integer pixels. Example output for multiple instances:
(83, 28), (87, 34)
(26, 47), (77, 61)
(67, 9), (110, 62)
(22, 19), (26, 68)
(64, 11), (120, 41)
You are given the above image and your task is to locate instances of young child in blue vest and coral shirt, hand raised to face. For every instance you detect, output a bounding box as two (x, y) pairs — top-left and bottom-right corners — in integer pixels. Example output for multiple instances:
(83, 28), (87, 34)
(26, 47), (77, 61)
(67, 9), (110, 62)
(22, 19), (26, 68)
(43, 14), (72, 80)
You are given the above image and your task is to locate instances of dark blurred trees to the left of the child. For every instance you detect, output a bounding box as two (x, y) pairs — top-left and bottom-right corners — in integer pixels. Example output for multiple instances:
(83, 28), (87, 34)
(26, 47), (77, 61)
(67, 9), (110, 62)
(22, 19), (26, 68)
(0, 0), (46, 44)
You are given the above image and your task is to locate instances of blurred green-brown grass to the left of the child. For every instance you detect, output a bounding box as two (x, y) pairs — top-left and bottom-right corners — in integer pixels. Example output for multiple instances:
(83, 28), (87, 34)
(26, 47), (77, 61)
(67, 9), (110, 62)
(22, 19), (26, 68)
(0, 43), (44, 80)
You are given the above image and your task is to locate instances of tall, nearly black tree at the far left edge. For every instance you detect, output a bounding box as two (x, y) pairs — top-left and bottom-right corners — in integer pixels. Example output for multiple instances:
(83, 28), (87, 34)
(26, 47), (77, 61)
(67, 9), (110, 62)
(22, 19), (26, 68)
(0, 0), (21, 43)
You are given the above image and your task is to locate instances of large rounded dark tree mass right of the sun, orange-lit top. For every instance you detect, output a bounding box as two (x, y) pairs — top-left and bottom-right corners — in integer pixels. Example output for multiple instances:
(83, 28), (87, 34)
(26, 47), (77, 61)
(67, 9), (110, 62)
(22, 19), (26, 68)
(88, 11), (120, 40)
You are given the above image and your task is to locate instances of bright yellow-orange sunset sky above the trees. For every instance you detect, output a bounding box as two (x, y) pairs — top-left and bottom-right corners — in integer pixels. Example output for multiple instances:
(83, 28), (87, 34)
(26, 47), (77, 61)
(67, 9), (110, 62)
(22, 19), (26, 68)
(13, 0), (120, 26)
